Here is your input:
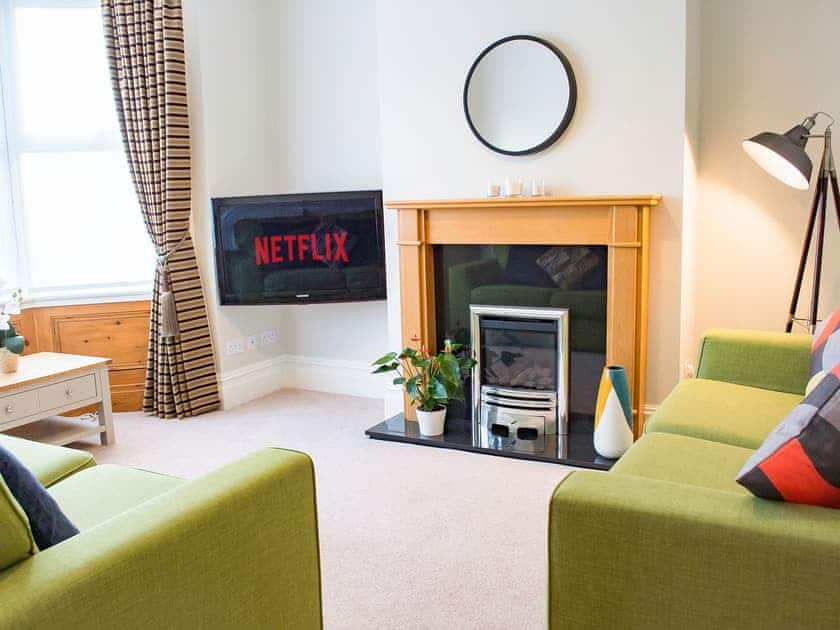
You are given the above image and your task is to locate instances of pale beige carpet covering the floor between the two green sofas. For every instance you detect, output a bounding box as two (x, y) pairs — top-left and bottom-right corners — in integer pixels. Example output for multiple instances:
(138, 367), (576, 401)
(79, 390), (570, 629)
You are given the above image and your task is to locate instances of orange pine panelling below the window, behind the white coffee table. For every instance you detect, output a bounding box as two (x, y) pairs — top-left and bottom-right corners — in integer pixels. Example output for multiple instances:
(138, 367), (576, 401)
(13, 300), (150, 411)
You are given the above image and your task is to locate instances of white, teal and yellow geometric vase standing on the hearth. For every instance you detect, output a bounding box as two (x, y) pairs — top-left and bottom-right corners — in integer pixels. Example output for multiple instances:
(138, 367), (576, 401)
(592, 365), (633, 459)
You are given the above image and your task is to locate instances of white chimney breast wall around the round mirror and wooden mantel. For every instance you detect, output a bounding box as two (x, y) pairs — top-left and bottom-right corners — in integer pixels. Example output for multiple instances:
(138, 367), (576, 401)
(377, 0), (686, 418)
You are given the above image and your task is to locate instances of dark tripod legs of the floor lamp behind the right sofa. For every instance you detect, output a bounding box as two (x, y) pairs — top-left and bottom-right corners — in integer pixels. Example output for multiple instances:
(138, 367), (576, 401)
(785, 126), (840, 335)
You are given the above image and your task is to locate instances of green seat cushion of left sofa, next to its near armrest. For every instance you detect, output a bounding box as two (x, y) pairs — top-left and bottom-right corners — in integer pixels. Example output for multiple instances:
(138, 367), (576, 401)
(50, 464), (184, 531)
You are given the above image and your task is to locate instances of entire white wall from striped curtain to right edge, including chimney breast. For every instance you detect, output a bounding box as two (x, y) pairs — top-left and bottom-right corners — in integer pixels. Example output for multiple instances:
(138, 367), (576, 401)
(177, 0), (840, 409)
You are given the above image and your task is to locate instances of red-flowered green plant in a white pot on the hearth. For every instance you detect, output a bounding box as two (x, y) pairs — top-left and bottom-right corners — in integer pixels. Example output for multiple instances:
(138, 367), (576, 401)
(373, 337), (475, 436)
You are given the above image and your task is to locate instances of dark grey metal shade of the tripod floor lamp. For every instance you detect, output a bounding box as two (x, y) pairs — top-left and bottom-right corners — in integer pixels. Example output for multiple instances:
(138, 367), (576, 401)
(742, 125), (813, 190)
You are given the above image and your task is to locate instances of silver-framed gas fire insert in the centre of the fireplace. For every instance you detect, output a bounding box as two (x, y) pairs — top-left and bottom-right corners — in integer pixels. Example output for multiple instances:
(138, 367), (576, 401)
(470, 305), (569, 451)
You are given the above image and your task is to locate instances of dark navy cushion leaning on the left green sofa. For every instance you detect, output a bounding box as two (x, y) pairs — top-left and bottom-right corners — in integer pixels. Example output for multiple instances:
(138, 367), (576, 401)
(0, 445), (79, 551)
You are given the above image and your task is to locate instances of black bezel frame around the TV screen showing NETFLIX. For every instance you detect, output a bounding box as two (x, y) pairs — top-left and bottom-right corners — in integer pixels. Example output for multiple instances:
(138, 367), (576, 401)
(210, 190), (388, 306)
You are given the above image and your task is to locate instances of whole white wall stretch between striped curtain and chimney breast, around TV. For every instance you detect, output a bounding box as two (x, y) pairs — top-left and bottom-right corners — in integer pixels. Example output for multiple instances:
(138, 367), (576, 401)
(184, 0), (386, 405)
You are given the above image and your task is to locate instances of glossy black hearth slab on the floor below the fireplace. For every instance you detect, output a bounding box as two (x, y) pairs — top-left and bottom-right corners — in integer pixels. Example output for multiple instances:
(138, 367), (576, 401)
(365, 413), (616, 470)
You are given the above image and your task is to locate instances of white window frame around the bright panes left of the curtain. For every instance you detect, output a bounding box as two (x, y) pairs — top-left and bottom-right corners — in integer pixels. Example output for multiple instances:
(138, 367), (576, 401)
(0, 0), (153, 306)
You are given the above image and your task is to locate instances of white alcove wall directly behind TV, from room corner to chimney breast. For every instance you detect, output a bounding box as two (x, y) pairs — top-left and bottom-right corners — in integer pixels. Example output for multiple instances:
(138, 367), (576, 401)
(268, 0), (387, 363)
